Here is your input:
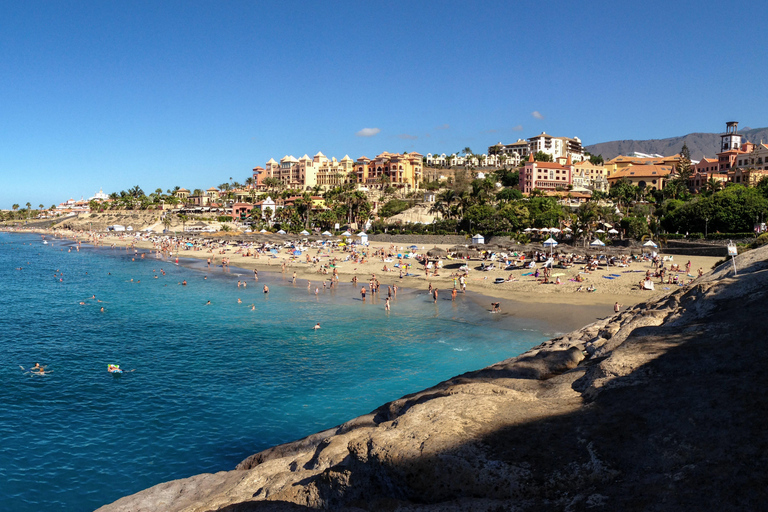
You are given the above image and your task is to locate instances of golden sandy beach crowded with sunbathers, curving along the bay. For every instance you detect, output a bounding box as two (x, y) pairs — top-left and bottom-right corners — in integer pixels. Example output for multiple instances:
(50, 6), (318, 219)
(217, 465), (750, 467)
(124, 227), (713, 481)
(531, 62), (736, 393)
(28, 226), (722, 330)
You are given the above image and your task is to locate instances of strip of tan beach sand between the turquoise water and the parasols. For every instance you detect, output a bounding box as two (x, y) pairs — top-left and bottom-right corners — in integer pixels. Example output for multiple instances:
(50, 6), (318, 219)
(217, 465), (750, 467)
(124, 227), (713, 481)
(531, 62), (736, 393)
(6, 225), (722, 332)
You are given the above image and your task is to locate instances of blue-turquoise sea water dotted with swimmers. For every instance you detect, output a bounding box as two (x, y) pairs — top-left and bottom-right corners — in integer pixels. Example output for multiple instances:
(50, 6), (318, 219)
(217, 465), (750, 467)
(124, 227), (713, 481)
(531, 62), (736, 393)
(0, 233), (552, 512)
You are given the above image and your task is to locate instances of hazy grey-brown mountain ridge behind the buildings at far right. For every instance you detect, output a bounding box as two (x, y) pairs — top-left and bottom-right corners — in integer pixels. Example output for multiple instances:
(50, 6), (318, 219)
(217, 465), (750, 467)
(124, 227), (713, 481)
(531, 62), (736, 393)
(584, 128), (768, 160)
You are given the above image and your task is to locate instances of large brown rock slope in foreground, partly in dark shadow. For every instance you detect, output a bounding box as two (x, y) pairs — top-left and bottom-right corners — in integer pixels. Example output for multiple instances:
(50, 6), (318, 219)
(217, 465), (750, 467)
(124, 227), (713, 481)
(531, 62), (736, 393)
(101, 247), (768, 511)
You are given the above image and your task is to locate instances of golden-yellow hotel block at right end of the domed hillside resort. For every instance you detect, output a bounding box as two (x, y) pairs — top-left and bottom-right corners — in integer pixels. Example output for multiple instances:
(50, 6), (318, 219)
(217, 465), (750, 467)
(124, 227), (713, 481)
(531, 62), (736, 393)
(355, 151), (422, 188)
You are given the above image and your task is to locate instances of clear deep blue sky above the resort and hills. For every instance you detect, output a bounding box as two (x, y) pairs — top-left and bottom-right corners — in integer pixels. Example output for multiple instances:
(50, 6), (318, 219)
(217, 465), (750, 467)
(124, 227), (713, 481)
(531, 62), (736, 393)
(0, 0), (768, 208)
